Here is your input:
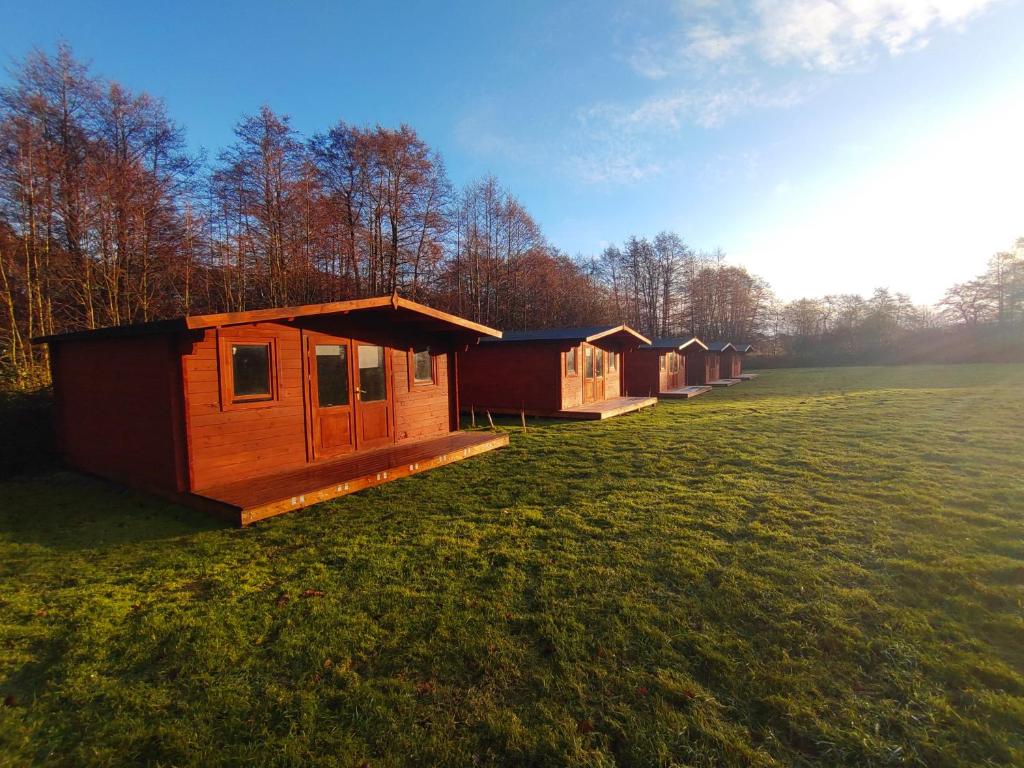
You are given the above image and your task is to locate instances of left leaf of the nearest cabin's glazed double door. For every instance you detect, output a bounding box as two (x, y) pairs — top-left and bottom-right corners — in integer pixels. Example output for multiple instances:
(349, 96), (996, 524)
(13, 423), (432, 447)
(306, 334), (355, 459)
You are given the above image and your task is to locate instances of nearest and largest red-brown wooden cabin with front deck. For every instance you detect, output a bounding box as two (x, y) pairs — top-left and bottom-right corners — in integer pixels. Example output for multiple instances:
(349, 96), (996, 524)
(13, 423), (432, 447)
(37, 296), (508, 525)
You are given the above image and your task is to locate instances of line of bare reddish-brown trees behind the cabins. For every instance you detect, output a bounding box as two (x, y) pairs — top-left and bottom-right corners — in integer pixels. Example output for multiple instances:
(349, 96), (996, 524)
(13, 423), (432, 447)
(0, 45), (1024, 388)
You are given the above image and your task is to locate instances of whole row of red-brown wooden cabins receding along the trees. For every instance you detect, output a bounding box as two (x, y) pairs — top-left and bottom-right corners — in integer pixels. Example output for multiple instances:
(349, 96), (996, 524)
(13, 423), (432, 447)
(35, 296), (750, 525)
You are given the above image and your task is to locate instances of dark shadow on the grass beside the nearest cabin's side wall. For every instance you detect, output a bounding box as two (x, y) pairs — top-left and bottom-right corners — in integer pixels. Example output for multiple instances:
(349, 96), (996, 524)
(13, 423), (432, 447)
(0, 471), (222, 552)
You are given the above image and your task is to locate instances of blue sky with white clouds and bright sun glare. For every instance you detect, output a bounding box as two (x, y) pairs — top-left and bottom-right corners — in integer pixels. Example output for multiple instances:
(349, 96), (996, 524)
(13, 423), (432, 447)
(0, 0), (1024, 302)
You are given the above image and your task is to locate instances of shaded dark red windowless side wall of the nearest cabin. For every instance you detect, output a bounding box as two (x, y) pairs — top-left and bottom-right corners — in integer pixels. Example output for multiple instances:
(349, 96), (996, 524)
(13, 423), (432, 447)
(50, 336), (187, 492)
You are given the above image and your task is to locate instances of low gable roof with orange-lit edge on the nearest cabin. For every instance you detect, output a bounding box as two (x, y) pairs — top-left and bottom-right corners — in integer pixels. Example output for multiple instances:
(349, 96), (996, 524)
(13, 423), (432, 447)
(32, 294), (502, 344)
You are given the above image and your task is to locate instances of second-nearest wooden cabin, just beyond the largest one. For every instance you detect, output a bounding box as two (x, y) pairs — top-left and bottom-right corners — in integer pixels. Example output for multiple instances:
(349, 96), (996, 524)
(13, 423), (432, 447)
(459, 326), (657, 419)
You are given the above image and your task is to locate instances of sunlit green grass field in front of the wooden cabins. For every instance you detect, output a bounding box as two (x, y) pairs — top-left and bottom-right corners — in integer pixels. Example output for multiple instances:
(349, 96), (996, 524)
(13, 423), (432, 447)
(0, 366), (1024, 766)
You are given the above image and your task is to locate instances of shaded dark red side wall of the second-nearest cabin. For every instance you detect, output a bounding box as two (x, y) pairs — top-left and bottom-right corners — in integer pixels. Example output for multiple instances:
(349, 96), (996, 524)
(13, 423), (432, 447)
(458, 342), (561, 413)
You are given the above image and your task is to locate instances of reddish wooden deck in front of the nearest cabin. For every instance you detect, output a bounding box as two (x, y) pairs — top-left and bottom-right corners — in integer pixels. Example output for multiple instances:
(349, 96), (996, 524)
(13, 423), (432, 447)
(194, 432), (509, 525)
